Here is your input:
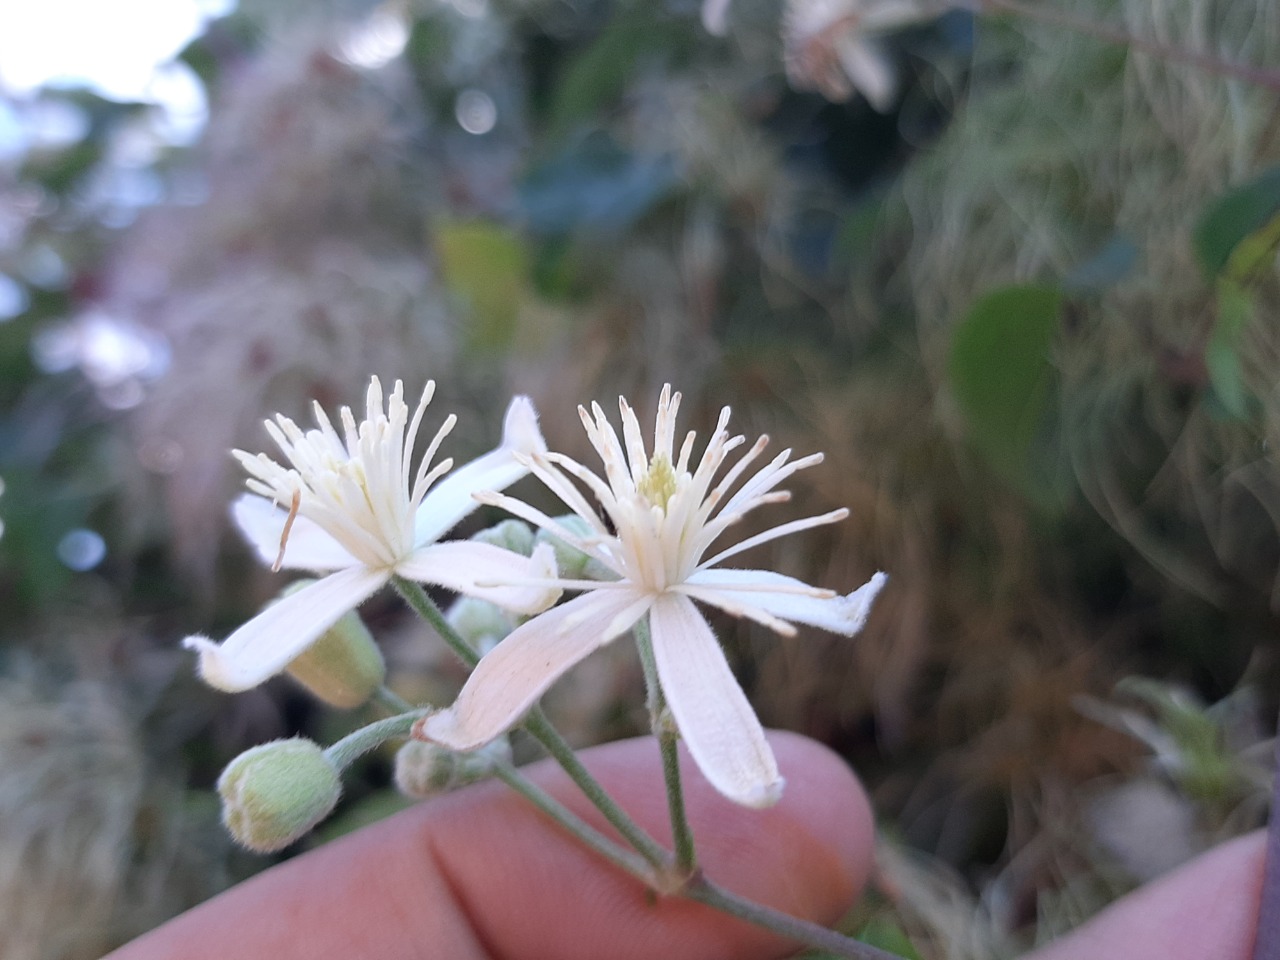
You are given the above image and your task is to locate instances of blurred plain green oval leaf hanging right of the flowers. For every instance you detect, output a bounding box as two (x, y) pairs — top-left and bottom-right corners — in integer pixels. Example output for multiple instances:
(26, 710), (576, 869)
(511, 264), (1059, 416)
(948, 285), (1062, 477)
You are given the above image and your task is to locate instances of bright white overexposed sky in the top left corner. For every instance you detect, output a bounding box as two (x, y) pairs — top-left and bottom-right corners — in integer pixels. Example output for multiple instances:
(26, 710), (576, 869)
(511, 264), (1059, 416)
(0, 0), (234, 100)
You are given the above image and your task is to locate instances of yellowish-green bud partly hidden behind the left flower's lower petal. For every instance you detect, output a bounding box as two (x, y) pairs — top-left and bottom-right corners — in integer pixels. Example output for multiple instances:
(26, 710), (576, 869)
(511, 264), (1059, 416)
(282, 580), (387, 710)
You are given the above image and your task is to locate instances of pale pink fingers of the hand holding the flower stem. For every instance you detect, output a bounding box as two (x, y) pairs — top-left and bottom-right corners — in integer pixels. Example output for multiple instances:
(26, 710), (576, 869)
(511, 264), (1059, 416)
(109, 733), (1263, 960)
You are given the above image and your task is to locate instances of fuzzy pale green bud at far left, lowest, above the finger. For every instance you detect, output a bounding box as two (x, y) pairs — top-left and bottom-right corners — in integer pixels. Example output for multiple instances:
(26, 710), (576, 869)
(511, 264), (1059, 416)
(218, 737), (342, 854)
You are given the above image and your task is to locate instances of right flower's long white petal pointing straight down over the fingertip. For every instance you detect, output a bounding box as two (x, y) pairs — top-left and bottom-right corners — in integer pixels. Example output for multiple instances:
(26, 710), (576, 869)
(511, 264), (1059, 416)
(649, 594), (783, 808)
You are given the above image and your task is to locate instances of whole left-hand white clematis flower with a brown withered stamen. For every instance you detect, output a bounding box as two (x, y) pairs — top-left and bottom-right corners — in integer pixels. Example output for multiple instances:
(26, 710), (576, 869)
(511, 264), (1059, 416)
(183, 376), (559, 692)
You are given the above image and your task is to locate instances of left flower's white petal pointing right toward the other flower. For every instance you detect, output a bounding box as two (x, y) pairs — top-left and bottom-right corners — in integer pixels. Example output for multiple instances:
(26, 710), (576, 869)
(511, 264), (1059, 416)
(396, 540), (561, 613)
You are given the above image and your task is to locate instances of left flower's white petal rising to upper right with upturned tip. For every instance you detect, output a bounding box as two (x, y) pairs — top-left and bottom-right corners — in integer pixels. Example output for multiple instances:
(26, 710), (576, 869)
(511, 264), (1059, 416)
(413, 397), (547, 544)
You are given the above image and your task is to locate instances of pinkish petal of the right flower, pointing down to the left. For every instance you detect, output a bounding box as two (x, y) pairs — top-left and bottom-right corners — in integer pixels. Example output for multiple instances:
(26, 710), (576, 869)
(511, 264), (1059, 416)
(420, 590), (649, 750)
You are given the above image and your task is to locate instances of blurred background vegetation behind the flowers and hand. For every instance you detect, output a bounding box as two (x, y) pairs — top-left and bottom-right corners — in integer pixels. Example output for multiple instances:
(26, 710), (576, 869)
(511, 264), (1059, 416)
(0, 0), (1280, 959)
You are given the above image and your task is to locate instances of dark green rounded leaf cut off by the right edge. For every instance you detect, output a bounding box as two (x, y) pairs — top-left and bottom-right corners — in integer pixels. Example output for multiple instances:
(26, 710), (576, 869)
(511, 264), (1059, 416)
(1194, 166), (1280, 279)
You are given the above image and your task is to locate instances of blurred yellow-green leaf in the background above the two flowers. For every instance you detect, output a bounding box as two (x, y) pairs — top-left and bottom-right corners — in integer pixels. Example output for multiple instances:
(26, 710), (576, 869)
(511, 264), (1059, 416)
(435, 220), (529, 351)
